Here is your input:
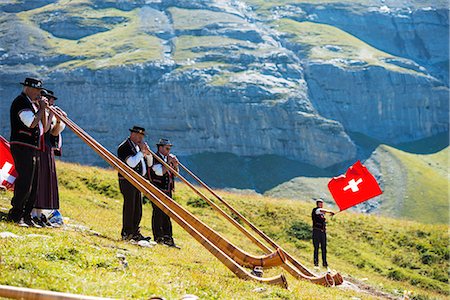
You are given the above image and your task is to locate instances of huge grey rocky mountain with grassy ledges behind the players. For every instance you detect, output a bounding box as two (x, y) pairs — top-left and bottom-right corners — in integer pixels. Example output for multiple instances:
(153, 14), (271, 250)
(0, 0), (448, 189)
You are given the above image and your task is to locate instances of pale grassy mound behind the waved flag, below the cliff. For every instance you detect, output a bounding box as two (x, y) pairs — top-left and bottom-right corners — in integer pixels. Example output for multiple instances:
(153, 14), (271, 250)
(266, 145), (450, 224)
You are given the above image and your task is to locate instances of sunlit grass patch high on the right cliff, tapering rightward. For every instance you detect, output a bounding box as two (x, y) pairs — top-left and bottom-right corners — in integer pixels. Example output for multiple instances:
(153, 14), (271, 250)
(274, 19), (425, 76)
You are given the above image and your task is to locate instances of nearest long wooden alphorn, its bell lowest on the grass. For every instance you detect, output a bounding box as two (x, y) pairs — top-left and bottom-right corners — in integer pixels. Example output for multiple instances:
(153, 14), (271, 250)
(50, 107), (287, 288)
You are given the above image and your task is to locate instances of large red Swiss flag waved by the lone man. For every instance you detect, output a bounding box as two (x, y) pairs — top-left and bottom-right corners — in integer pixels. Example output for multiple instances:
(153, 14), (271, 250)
(328, 160), (383, 211)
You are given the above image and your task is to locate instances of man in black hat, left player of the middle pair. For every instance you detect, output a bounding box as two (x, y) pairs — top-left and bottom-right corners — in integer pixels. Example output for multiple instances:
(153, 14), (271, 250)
(117, 126), (153, 241)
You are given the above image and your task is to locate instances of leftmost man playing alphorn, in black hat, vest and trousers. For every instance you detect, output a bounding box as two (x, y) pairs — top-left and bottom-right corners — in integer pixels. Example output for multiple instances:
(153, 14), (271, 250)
(8, 78), (48, 227)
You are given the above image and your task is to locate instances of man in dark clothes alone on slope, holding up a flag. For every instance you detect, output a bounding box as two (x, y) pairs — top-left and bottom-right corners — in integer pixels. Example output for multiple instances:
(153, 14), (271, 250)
(311, 198), (334, 268)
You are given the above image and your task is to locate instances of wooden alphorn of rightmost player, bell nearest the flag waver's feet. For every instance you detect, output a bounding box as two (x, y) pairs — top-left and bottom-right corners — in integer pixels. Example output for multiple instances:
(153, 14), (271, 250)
(179, 163), (344, 285)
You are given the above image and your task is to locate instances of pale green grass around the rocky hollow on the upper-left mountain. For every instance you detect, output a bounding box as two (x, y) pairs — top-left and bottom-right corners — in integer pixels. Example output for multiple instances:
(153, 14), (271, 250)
(18, 1), (163, 70)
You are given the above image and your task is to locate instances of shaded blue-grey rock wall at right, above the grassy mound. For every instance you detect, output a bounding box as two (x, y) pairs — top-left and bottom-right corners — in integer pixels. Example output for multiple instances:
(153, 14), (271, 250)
(305, 63), (449, 143)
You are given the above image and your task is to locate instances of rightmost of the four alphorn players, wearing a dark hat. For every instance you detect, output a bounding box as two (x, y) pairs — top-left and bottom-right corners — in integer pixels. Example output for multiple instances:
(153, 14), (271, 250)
(149, 138), (179, 248)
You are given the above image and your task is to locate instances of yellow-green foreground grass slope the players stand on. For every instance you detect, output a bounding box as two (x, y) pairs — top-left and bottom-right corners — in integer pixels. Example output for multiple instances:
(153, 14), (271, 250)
(0, 163), (449, 299)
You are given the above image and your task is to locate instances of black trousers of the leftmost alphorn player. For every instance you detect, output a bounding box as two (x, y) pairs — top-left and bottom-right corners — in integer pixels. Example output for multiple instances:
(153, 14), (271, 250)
(8, 144), (39, 222)
